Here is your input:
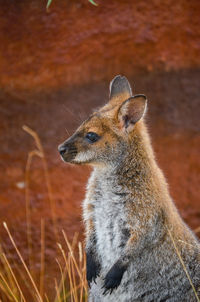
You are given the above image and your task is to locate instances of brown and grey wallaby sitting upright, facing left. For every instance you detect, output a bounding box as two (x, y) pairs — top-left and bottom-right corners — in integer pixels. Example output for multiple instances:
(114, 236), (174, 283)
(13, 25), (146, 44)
(59, 76), (200, 302)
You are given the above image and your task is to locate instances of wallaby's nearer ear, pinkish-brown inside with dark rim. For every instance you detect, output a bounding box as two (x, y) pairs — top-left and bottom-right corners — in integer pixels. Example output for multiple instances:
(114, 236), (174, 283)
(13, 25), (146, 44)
(118, 94), (147, 132)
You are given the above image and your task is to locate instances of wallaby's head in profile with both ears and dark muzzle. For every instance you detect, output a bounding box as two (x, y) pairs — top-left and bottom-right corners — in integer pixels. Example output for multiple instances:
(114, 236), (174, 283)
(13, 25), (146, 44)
(58, 76), (147, 165)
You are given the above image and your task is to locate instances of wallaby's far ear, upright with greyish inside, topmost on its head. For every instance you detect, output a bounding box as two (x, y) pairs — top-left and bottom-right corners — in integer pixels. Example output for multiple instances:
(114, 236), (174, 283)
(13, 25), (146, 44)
(110, 75), (132, 100)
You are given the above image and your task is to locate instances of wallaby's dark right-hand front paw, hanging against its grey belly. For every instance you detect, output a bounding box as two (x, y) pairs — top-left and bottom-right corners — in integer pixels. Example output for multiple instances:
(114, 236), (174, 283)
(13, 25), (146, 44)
(102, 262), (125, 295)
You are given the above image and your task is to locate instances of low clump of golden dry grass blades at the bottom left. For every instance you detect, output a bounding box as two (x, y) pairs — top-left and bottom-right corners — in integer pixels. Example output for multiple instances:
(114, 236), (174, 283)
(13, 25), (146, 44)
(0, 222), (87, 302)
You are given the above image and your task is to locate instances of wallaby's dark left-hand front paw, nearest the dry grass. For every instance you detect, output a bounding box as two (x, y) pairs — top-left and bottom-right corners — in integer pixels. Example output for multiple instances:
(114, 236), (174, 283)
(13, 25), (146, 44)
(86, 252), (100, 287)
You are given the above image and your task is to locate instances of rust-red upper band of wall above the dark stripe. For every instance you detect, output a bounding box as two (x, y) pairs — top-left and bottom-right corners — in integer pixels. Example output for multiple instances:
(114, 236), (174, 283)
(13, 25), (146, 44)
(0, 0), (200, 90)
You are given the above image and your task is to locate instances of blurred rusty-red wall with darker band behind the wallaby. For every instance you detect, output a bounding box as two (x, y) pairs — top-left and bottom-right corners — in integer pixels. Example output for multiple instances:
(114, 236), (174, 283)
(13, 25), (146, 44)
(0, 0), (200, 302)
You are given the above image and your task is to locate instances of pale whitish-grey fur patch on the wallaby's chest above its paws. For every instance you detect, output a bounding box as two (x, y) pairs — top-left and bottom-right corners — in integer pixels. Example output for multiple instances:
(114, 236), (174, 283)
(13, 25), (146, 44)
(94, 185), (129, 268)
